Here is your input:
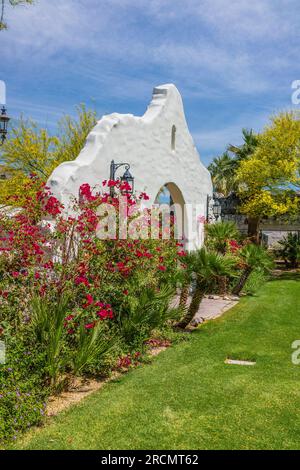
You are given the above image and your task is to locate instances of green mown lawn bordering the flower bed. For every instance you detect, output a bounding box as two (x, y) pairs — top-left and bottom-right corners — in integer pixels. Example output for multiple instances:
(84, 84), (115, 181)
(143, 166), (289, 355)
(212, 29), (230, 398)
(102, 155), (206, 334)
(11, 276), (300, 450)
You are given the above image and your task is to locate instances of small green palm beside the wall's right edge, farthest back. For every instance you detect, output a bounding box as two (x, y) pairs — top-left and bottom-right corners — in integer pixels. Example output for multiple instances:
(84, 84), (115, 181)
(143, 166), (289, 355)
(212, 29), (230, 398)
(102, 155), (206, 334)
(205, 222), (239, 254)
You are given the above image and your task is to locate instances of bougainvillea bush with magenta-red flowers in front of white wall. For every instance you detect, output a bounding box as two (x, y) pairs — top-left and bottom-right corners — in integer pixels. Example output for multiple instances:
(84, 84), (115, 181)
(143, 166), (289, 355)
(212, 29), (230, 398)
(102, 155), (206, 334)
(0, 176), (185, 440)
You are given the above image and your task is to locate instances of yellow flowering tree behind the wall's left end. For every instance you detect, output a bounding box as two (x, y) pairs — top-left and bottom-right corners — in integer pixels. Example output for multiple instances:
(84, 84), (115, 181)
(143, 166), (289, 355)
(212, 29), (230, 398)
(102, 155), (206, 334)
(0, 105), (96, 204)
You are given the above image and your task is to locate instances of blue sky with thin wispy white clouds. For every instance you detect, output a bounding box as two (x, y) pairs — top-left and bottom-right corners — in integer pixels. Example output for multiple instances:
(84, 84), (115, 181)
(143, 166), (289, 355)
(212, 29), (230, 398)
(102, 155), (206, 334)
(0, 0), (300, 164)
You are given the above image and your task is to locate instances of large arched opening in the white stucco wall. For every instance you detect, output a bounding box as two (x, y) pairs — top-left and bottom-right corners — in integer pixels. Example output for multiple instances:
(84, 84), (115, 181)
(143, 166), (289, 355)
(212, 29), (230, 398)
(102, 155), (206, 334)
(155, 182), (187, 241)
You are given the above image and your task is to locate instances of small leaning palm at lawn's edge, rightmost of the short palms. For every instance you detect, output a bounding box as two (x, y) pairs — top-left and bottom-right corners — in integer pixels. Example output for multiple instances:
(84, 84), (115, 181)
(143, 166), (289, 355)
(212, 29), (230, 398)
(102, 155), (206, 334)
(232, 243), (273, 295)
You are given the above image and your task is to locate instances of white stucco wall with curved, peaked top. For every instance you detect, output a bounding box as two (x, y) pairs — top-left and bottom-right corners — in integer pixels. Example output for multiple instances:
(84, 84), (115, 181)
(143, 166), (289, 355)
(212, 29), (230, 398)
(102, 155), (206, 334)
(48, 84), (212, 249)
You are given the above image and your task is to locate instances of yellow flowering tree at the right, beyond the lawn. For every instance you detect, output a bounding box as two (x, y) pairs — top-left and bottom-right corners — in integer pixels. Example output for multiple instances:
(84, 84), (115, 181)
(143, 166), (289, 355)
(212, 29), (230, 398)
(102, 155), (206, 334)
(237, 112), (300, 241)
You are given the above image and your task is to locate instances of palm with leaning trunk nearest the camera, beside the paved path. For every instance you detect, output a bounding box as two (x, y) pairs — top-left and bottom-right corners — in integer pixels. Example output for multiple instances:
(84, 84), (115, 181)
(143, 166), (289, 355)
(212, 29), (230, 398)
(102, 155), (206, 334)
(177, 248), (235, 329)
